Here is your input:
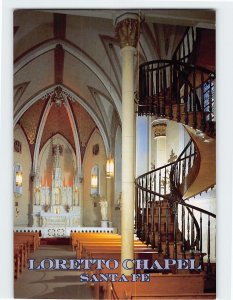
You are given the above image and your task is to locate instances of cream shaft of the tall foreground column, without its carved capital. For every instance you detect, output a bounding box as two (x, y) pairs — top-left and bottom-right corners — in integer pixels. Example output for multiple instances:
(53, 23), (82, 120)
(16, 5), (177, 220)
(121, 46), (136, 274)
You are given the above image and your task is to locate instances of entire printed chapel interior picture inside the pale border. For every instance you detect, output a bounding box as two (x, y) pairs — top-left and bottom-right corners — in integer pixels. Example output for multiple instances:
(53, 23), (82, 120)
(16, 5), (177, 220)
(13, 9), (217, 299)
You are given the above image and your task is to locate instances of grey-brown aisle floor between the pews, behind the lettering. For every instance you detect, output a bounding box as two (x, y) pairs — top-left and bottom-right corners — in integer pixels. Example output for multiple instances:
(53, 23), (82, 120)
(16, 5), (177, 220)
(14, 245), (94, 299)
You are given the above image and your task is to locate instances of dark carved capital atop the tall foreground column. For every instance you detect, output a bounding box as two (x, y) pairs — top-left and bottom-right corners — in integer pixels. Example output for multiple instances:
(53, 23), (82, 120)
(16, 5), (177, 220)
(115, 13), (139, 48)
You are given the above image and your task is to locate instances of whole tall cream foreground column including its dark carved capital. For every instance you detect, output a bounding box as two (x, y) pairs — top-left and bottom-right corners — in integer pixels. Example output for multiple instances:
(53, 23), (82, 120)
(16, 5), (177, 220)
(116, 13), (139, 275)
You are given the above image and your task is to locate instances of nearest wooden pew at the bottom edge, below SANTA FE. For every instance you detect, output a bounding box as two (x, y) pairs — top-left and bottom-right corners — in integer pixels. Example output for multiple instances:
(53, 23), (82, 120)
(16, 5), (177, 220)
(104, 273), (204, 300)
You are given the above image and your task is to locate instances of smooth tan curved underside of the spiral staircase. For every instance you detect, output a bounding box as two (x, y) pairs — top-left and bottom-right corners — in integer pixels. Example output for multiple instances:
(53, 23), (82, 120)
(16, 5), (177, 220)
(183, 125), (216, 200)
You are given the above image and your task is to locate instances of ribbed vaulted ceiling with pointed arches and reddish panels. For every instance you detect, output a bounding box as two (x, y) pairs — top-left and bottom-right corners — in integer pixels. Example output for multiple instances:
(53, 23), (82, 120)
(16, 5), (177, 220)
(14, 10), (215, 163)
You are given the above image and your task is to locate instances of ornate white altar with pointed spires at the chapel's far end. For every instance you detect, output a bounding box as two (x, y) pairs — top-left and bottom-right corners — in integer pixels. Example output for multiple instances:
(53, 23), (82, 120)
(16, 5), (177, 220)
(32, 145), (81, 227)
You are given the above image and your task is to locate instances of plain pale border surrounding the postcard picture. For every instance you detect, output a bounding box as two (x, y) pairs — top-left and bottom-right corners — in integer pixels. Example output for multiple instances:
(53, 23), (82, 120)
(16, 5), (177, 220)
(0, 0), (233, 299)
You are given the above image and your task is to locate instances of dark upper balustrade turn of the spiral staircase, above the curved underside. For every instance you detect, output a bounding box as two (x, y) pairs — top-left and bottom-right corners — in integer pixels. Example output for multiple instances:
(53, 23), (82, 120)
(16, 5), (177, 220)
(135, 60), (215, 136)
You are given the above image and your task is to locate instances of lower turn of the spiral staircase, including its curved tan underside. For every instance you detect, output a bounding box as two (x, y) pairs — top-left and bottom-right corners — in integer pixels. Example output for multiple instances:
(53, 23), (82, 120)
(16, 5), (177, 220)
(135, 128), (216, 274)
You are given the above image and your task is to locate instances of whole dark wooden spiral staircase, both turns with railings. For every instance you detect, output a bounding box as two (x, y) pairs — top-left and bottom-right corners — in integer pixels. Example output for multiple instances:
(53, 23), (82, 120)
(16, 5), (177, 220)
(135, 27), (216, 291)
